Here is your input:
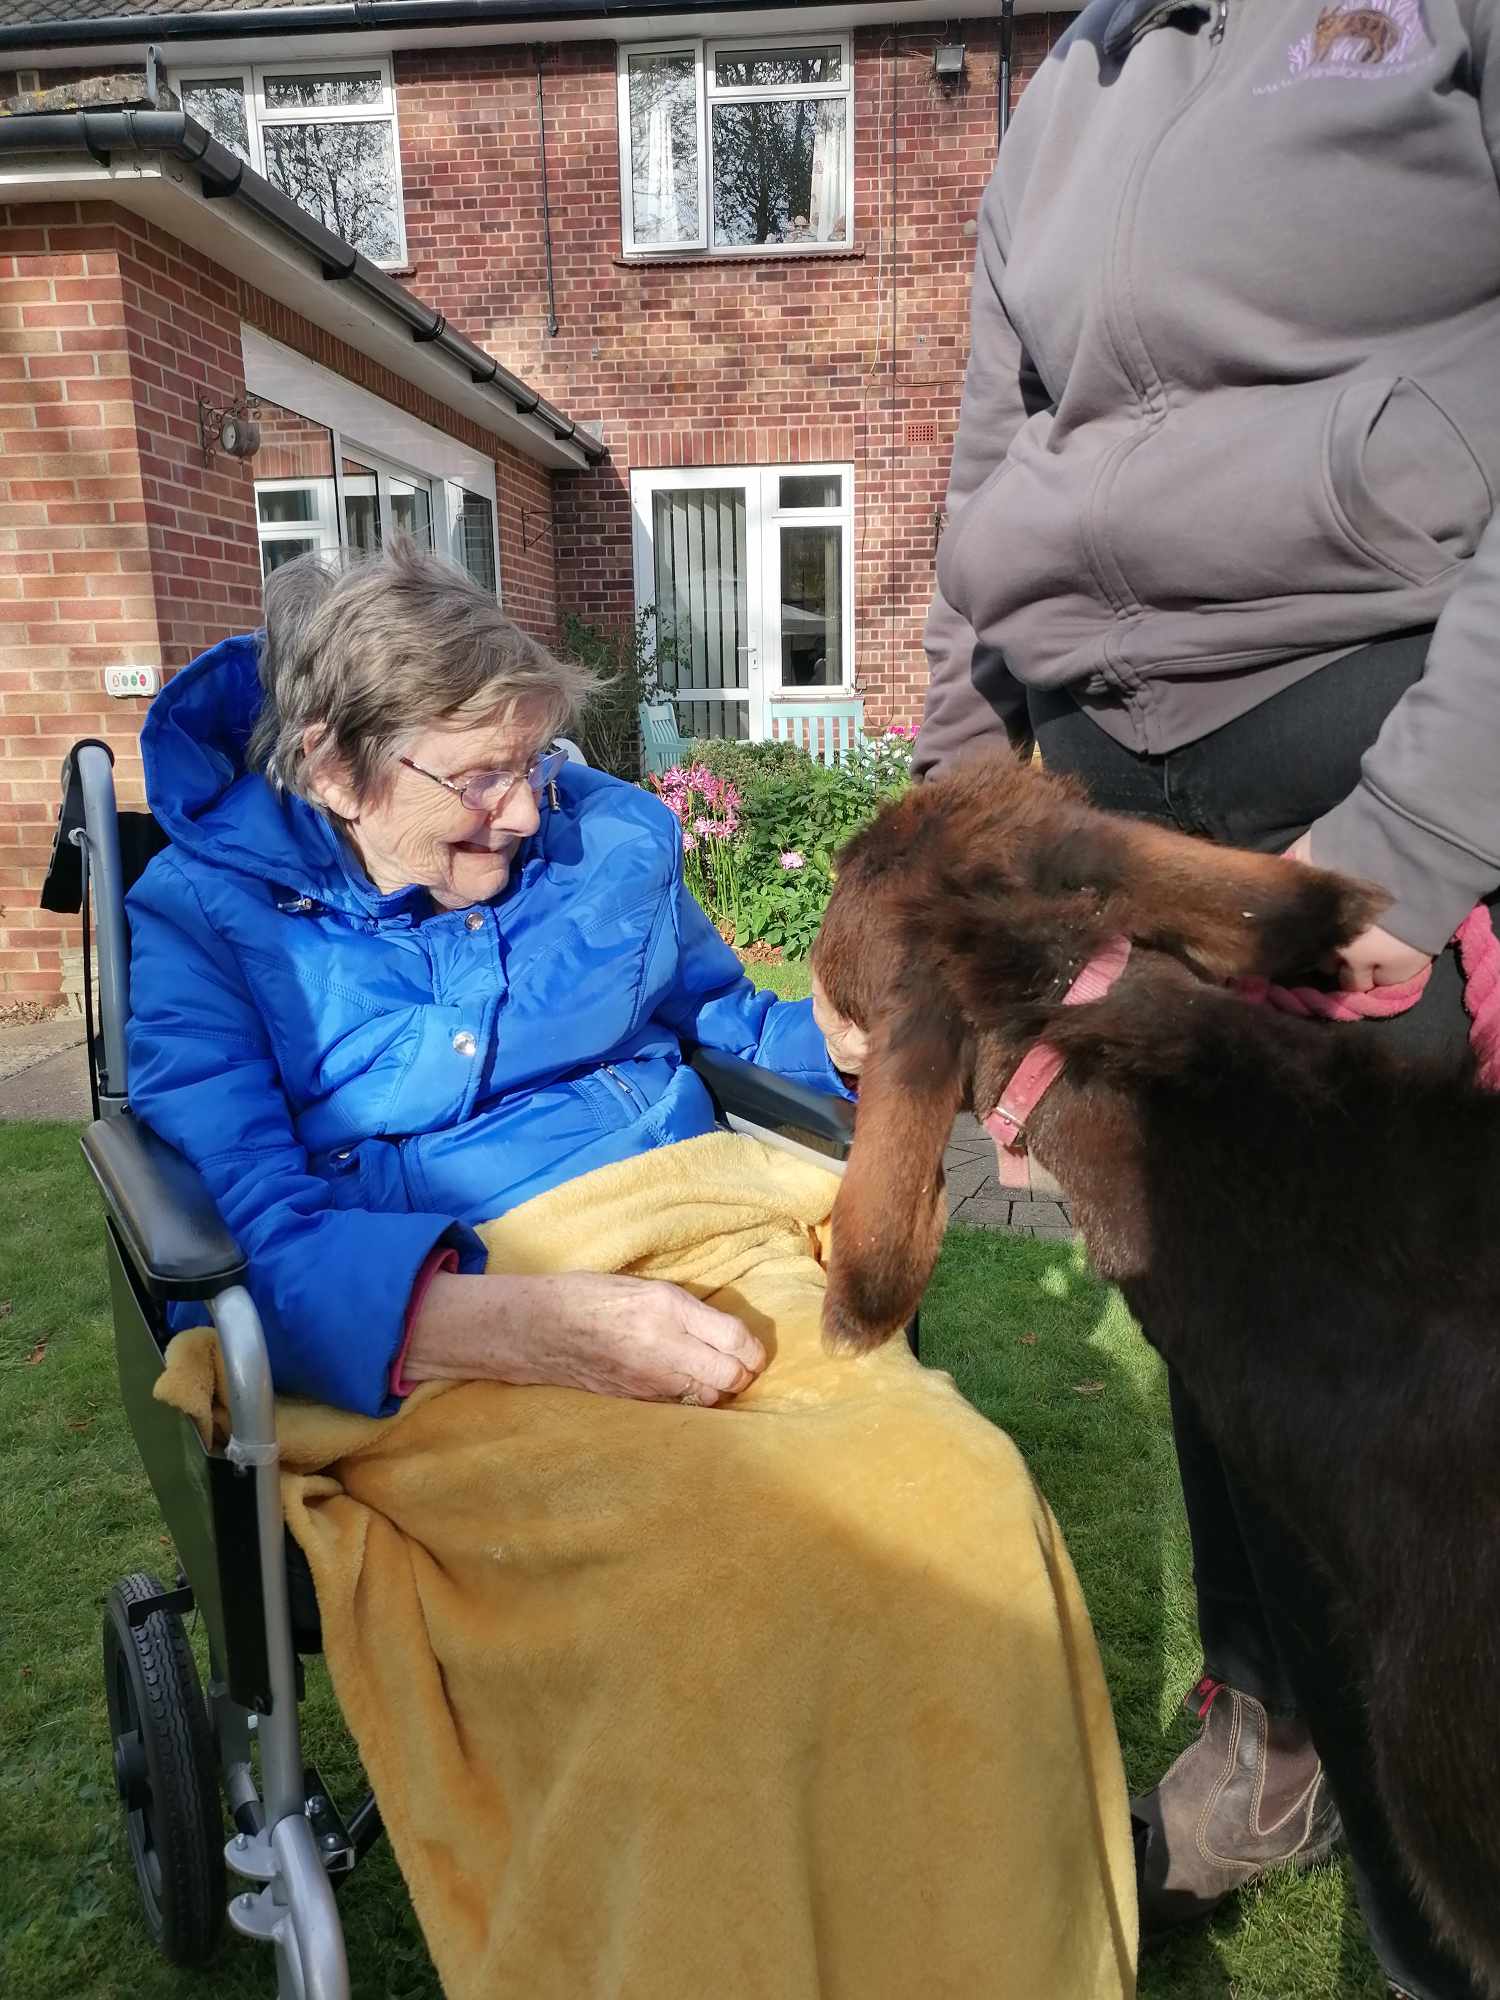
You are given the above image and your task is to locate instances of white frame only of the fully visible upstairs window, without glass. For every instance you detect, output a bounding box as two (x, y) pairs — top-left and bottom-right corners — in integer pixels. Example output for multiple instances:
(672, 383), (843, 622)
(620, 34), (854, 258)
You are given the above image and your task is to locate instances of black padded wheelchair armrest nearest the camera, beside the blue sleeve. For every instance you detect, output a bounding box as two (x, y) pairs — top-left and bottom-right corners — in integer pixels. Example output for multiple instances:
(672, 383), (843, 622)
(82, 1114), (246, 1300)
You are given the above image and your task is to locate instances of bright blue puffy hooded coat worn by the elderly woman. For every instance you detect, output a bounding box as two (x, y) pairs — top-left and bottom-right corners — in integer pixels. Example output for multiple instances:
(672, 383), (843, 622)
(128, 638), (838, 1412)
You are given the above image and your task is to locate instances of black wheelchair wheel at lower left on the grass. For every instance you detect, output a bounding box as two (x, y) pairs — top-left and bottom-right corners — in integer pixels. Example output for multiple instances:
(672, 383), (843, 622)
(104, 1572), (226, 1966)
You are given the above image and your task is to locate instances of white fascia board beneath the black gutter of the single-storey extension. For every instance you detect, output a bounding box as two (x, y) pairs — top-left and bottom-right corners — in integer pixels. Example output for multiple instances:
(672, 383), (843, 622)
(0, 154), (588, 472)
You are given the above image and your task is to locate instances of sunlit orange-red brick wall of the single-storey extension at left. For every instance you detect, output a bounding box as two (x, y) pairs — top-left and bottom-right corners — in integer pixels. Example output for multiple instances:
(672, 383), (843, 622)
(0, 202), (558, 1008)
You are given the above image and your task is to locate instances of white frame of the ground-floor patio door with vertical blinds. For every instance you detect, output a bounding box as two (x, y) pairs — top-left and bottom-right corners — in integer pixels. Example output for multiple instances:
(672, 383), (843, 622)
(630, 462), (858, 742)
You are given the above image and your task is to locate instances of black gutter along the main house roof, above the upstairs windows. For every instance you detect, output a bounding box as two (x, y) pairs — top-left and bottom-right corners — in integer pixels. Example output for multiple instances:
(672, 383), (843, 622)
(0, 0), (892, 52)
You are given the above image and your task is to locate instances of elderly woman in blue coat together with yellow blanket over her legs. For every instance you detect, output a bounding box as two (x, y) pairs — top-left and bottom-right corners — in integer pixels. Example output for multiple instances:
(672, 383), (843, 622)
(130, 546), (1132, 2000)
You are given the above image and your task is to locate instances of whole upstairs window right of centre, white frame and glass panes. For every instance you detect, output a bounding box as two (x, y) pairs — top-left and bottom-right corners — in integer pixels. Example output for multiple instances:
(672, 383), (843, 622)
(620, 36), (854, 254)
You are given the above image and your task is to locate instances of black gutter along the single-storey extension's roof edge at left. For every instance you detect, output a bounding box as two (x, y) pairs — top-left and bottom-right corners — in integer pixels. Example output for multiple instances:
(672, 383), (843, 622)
(0, 110), (608, 466)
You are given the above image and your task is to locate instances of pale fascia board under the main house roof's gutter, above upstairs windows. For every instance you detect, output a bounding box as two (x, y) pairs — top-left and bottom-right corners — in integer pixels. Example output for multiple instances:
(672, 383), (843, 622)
(6, 0), (1024, 70)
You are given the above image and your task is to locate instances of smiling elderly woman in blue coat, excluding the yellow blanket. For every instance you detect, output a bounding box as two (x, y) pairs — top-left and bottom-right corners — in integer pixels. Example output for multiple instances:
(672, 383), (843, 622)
(130, 546), (850, 1412)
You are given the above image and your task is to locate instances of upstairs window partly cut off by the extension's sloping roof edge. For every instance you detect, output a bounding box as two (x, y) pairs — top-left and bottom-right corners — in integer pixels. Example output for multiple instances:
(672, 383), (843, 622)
(174, 56), (406, 264)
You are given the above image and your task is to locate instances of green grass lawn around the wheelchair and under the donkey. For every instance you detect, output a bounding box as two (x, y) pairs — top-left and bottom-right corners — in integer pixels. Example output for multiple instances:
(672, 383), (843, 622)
(0, 1120), (1384, 2000)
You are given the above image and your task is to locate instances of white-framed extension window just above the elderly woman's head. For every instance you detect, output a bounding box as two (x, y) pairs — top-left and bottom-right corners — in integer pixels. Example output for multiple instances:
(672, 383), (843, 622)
(240, 326), (500, 594)
